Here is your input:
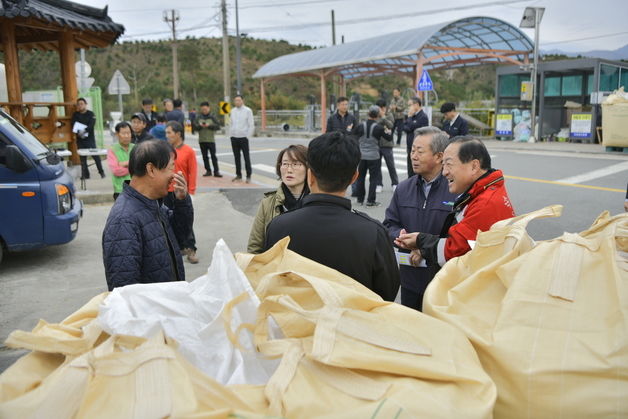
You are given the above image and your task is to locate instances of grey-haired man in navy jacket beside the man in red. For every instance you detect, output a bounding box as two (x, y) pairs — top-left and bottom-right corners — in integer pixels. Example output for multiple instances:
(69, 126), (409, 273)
(384, 127), (456, 310)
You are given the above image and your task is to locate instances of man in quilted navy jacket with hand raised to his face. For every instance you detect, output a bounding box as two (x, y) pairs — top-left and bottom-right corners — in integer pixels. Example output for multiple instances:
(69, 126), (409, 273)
(102, 140), (192, 291)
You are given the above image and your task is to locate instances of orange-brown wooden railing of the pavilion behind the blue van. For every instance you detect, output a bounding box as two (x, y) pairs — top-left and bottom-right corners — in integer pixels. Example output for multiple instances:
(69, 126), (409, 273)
(0, 102), (75, 144)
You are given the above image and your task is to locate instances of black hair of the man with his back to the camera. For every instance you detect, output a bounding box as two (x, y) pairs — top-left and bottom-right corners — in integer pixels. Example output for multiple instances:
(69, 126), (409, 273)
(307, 131), (362, 193)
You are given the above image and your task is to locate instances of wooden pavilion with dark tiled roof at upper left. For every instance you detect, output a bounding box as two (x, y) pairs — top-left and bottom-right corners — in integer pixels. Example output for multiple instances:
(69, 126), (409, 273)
(0, 0), (124, 162)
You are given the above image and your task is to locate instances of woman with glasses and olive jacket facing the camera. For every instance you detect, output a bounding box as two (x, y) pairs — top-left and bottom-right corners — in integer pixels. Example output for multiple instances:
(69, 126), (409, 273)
(248, 145), (310, 253)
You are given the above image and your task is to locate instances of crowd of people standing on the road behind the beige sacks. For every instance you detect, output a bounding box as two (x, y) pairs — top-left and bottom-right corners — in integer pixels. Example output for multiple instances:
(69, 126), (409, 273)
(99, 89), (514, 310)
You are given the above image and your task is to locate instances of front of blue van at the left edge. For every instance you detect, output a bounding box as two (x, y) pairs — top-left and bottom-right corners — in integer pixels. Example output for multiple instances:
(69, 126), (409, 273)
(0, 110), (83, 262)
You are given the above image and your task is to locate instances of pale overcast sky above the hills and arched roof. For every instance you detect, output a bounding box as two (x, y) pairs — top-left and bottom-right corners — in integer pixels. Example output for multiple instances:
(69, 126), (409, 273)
(75, 0), (628, 52)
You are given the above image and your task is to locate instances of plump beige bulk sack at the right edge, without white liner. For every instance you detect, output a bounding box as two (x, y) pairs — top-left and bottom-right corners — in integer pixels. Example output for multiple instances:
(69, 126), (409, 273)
(423, 206), (628, 419)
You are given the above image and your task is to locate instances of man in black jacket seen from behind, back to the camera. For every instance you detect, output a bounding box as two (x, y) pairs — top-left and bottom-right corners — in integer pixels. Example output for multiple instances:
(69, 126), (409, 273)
(265, 131), (399, 301)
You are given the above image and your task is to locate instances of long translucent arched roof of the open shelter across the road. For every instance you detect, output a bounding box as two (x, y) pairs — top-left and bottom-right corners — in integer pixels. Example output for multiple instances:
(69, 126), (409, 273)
(253, 16), (534, 79)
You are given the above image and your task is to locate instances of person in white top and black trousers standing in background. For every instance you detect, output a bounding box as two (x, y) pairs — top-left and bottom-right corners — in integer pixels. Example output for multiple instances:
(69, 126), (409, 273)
(229, 95), (255, 183)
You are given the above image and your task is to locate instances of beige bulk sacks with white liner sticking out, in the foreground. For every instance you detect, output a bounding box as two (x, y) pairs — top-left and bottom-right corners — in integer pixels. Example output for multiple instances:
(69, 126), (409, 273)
(0, 239), (496, 418)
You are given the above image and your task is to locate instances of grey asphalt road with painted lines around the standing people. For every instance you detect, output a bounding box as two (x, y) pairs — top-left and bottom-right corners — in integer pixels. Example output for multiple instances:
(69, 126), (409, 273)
(0, 134), (628, 371)
